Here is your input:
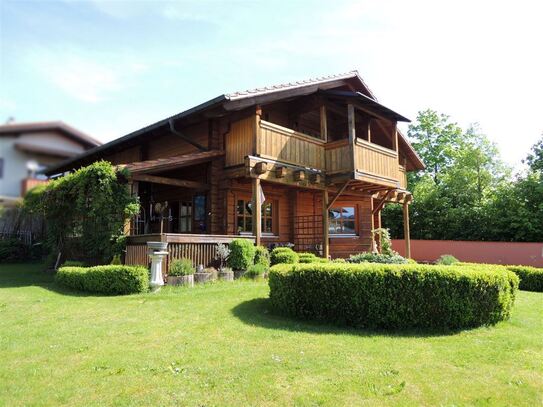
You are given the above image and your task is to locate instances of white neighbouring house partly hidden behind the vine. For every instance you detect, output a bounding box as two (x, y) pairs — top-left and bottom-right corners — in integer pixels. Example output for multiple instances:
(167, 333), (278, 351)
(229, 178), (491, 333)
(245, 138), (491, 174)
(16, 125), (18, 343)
(0, 122), (101, 207)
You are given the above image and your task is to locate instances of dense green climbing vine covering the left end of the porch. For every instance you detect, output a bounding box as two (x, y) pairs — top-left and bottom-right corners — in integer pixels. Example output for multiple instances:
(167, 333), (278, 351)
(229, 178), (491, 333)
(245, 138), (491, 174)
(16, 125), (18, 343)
(24, 161), (139, 264)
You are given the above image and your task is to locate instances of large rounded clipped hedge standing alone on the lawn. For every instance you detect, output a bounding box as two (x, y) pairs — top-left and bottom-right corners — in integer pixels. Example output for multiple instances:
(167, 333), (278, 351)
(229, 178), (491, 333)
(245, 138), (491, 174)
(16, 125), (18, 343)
(269, 263), (518, 329)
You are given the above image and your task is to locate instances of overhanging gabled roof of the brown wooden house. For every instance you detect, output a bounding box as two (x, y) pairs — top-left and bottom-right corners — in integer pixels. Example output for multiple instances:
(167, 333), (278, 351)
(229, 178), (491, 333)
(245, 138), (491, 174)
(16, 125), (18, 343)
(47, 71), (424, 175)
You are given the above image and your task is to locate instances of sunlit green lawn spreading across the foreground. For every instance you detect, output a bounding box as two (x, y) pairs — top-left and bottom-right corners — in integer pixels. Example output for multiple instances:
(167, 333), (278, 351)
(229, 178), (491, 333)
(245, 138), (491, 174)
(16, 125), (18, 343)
(0, 265), (543, 406)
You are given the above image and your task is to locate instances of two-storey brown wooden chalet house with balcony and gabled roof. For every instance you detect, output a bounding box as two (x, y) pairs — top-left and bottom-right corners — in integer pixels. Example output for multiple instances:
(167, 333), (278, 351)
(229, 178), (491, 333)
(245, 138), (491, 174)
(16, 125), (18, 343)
(49, 71), (424, 265)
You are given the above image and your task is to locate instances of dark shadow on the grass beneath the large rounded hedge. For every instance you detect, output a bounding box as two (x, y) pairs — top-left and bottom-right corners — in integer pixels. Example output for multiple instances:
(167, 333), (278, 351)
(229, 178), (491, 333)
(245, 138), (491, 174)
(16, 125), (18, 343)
(231, 298), (461, 338)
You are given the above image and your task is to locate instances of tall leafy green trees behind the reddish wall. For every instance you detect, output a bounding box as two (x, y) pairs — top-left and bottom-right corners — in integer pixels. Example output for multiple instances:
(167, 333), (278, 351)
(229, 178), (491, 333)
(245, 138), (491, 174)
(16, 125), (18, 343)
(382, 110), (543, 242)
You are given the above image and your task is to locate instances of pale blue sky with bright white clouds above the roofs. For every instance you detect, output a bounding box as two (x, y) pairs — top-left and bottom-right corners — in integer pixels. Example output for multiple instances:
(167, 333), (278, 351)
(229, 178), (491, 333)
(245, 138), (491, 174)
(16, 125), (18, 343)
(0, 0), (543, 166)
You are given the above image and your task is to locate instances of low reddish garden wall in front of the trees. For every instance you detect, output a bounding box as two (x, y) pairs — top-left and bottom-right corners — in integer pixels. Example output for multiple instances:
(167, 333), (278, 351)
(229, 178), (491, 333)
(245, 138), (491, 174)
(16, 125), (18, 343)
(392, 240), (543, 267)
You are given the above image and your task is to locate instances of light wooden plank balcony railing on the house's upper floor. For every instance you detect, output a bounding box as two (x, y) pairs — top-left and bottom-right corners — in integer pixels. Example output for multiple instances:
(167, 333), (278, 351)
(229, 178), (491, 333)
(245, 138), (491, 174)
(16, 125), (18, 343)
(226, 116), (407, 189)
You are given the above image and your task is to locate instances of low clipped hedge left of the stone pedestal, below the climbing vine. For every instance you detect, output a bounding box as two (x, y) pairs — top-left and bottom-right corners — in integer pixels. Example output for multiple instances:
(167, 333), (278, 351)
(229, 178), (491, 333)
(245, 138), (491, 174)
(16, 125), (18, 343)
(55, 265), (149, 295)
